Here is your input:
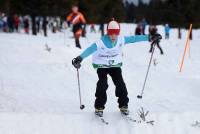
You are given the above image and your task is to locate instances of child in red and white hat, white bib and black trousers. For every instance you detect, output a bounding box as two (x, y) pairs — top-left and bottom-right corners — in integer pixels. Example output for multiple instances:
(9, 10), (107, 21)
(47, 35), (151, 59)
(72, 20), (161, 117)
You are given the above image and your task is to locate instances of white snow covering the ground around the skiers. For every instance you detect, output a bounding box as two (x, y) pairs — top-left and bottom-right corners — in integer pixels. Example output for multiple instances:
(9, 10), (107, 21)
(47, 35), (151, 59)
(0, 24), (200, 134)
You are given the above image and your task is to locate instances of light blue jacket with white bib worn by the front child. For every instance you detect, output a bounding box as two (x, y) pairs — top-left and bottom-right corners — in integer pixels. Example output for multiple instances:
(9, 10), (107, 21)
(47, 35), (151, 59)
(80, 35), (149, 68)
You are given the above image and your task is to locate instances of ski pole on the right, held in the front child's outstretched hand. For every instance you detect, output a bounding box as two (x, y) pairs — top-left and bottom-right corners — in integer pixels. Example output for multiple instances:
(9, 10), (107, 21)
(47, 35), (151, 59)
(137, 41), (158, 99)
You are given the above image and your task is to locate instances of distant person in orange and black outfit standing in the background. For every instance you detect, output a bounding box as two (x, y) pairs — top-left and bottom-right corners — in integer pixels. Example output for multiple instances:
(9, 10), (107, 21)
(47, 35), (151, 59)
(67, 5), (86, 48)
